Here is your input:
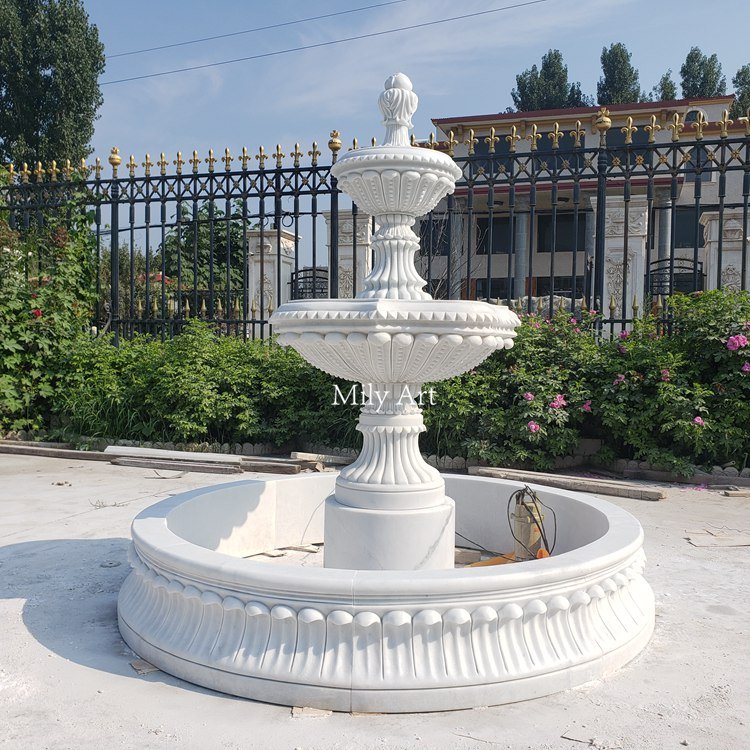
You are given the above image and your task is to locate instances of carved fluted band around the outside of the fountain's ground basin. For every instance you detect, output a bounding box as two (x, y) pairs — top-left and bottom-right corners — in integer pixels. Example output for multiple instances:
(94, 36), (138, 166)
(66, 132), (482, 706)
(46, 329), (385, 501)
(118, 553), (654, 690)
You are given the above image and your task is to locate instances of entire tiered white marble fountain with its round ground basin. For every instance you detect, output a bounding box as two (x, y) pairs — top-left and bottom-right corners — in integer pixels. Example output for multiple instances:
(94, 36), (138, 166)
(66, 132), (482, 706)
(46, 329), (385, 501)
(118, 74), (654, 712)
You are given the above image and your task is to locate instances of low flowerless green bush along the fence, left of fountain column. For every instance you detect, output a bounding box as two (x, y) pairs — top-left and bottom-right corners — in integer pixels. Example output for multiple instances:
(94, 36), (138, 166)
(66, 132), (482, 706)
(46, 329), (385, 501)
(57, 322), (362, 452)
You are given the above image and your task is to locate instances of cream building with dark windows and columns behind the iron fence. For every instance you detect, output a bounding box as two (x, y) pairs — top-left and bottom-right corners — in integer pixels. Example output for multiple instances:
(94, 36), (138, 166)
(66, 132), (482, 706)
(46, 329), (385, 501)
(420, 96), (750, 320)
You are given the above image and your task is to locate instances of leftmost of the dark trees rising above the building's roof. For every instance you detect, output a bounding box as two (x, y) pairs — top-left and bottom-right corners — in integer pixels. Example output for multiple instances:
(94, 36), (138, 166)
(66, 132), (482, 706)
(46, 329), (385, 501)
(511, 49), (591, 112)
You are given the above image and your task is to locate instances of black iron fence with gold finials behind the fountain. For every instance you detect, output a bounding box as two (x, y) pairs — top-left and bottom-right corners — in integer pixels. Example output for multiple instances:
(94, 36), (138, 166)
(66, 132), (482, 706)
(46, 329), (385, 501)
(0, 110), (750, 338)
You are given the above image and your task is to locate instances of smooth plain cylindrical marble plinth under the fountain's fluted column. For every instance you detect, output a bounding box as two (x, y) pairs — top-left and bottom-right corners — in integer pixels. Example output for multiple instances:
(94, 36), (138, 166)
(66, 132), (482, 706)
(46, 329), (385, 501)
(324, 497), (456, 570)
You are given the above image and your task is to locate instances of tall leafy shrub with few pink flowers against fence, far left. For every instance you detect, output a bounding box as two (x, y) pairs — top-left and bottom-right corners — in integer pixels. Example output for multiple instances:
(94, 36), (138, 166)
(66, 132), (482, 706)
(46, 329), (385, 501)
(0, 194), (94, 430)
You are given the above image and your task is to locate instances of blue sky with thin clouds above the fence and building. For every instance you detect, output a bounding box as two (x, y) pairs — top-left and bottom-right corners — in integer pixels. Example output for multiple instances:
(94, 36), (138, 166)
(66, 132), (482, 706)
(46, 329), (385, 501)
(84, 0), (750, 170)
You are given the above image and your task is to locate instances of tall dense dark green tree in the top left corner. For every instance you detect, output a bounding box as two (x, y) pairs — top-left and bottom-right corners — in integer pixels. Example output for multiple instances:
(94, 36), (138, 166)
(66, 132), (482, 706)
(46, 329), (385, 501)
(0, 0), (104, 164)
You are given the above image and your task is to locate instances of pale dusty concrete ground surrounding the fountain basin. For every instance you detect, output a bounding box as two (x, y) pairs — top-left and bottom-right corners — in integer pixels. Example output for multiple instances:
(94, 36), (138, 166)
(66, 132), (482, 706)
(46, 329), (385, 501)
(0, 454), (750, 750)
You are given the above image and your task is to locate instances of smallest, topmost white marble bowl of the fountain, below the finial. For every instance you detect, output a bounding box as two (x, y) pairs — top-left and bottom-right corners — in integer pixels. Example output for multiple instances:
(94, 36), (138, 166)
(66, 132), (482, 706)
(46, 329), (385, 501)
(331, 145), (461, 217)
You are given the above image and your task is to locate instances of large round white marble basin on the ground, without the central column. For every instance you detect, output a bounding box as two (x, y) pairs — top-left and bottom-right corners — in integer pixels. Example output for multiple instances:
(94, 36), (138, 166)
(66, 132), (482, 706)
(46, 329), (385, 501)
(118, 473), (654, 713)
